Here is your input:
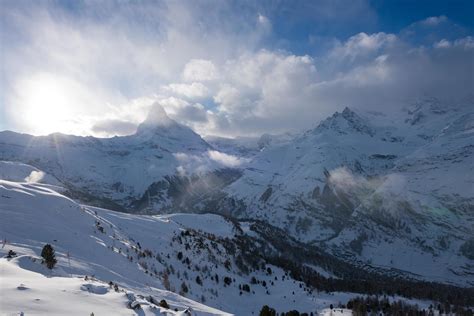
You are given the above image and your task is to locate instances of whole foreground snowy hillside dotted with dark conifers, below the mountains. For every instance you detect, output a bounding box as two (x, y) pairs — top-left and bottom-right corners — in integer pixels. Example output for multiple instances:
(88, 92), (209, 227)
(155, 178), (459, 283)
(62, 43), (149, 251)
(0, 164), (472, 315)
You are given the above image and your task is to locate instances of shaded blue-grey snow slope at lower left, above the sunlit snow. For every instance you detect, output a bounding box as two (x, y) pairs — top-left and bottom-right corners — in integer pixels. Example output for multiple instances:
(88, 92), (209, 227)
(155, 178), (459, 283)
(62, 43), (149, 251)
(0, 181), (226, 314)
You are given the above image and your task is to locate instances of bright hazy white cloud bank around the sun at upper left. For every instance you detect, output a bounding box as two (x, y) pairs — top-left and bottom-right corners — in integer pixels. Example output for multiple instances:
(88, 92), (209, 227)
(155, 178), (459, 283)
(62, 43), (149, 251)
(0, 2), (258, 135)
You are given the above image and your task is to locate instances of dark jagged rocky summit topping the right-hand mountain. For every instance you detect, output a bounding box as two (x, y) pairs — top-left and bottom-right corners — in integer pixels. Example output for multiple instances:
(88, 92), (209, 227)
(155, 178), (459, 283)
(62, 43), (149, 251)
(316, 106), (375, 136)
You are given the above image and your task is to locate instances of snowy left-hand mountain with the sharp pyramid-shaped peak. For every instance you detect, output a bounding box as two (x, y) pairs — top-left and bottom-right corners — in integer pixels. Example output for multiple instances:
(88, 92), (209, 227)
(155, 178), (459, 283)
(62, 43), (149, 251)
(0, 105), (239, 209)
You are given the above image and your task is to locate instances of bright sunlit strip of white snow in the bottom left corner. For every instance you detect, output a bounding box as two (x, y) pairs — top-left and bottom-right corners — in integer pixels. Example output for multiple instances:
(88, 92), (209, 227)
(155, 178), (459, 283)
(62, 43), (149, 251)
(0, 256), (205, 315)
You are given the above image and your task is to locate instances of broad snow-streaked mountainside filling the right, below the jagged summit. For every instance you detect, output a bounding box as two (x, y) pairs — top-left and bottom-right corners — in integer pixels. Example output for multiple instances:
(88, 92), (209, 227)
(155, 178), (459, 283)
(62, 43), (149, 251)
(217, 99), (474, 285)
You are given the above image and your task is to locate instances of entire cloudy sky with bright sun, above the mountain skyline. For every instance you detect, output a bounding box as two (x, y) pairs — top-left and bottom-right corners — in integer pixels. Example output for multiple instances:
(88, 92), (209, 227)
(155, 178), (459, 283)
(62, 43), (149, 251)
(0, 0), (474, 136)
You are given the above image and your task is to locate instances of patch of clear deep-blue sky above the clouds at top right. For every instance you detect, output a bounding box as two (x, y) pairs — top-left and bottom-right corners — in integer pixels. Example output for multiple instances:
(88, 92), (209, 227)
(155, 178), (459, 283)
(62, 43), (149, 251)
(256, 0), (474, 53)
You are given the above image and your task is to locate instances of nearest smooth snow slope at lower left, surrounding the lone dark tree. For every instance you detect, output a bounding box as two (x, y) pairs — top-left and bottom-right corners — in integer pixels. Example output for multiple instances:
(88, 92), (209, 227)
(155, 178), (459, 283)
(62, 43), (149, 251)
(0, 180), (225, 315)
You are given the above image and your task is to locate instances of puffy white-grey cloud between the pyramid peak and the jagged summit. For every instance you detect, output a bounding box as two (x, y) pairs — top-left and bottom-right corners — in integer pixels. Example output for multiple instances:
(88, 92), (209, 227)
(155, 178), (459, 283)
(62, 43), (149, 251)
(214, 50), (317, 124)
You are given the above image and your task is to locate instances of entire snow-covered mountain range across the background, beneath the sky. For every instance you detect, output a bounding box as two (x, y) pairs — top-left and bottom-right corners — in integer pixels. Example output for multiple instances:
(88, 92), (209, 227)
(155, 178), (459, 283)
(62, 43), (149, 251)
(0, 98), (474, 304)
